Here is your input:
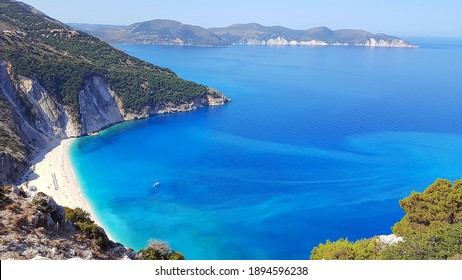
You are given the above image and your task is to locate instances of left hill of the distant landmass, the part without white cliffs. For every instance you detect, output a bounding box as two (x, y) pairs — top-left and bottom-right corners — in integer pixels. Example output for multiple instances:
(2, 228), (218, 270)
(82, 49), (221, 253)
(70, 19), (228, 46)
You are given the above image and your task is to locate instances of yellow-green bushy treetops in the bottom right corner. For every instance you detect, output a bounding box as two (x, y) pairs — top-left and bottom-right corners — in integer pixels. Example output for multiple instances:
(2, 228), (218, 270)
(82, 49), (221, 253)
(311, 179), (462, 260)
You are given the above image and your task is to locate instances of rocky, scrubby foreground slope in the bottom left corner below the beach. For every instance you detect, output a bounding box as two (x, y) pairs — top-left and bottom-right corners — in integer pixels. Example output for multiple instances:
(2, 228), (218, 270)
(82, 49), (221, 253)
(0, 187), (137, 260)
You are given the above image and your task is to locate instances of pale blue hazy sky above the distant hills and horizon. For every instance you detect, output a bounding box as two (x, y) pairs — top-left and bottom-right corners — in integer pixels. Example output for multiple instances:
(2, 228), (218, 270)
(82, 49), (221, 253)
(19, 0), (462, 37)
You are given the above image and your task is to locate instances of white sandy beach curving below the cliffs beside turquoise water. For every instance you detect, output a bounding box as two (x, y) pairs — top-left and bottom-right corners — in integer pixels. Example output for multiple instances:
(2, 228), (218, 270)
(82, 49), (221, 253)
(20, 138), (110, 238)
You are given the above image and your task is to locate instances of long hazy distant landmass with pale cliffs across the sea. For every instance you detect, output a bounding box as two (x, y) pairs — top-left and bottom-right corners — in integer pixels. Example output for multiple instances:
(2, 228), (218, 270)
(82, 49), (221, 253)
(69, 19), (417, 48)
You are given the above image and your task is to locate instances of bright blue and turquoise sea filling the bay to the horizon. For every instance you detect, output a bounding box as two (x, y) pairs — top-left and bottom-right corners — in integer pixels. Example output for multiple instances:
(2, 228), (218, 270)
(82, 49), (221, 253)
(71, 39), (462, 259)
